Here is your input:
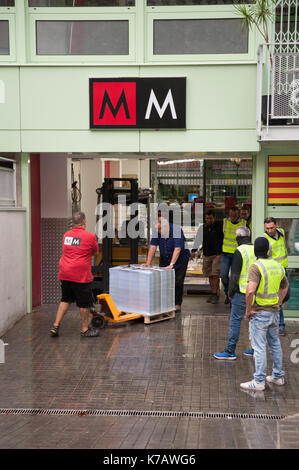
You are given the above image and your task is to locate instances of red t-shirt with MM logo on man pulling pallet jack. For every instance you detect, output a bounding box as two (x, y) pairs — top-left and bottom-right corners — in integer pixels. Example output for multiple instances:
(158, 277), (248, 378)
(58, 227), (98, 282)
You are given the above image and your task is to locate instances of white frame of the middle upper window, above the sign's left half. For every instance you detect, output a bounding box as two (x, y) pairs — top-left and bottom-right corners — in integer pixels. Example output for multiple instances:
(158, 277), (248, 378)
(28, 7), (136, 65)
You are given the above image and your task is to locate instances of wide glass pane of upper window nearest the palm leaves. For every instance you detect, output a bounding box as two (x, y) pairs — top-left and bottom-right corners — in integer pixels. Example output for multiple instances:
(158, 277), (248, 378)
(154, 19), (248, 55)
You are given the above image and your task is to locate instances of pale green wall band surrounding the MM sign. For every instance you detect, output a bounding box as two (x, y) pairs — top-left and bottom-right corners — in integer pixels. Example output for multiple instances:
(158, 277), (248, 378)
(0, 65), (259, 152)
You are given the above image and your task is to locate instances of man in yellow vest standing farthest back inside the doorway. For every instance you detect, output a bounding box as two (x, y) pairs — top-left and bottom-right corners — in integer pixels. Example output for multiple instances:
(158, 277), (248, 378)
(220, 206), (246, 304)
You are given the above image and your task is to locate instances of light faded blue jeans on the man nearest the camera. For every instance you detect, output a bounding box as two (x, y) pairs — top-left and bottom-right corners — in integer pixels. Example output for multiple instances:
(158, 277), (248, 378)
(249, 310), (284, 384)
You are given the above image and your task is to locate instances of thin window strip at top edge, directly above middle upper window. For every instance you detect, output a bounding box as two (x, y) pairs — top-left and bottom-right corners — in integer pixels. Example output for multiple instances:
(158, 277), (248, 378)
(28, 0), (135, 7)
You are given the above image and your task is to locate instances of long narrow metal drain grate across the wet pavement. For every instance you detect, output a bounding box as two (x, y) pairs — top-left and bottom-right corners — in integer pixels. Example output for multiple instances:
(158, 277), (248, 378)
(0, 408), (285, 420)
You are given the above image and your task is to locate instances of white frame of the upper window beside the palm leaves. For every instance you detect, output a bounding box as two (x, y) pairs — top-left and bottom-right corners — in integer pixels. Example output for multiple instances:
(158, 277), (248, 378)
(146, 5), (257, 63)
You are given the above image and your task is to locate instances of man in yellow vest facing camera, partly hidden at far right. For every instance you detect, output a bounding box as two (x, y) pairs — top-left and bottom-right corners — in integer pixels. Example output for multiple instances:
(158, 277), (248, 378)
(264, 217), (290, 336)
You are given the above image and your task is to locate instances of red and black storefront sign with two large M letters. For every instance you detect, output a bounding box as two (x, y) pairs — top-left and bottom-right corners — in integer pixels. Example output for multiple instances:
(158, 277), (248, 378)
(89, 77), (186, 129)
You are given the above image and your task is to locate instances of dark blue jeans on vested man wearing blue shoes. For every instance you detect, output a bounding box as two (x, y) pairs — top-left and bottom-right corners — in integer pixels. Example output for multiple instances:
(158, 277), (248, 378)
(225, 292), (246, 354)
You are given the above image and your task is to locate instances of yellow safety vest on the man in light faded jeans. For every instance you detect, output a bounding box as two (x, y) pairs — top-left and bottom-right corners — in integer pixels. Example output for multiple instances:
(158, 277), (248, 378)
(254, 258), (285, 306)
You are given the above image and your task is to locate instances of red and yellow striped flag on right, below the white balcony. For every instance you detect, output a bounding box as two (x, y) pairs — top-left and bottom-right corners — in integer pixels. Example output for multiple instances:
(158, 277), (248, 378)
(268, 155), (299, 204)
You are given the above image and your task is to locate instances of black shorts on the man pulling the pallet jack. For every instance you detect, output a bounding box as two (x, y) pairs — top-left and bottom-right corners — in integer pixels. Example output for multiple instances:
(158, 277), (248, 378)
(61, 281), (93, 308)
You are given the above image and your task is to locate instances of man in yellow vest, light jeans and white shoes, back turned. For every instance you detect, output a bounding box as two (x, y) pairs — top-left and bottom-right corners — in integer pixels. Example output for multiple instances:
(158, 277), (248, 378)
(240, 237), (289, 390)
